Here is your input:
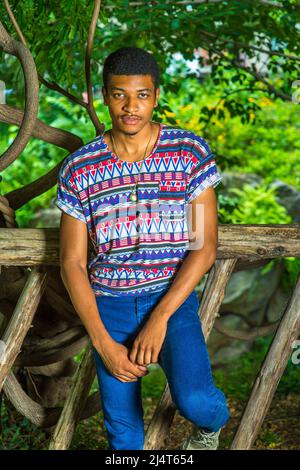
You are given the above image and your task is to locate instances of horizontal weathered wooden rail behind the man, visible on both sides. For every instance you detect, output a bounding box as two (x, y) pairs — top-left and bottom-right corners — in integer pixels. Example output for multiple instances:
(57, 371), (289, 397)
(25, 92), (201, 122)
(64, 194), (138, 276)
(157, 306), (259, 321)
(0, 224), (300, 266)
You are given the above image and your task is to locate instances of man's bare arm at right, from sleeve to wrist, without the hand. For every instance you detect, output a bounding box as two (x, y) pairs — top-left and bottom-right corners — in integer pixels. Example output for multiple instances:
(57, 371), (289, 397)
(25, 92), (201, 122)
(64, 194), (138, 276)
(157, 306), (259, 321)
(151, 187), (218, 320)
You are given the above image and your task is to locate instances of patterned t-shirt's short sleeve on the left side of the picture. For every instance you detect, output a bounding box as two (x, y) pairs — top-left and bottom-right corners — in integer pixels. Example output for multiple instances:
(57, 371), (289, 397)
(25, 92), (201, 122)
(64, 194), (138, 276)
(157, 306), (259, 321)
(54, 160), (86, 223)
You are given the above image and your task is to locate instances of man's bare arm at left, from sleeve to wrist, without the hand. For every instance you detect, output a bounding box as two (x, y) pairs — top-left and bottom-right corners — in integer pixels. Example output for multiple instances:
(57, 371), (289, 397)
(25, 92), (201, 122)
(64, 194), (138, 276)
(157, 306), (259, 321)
(60, 213), (111, 349)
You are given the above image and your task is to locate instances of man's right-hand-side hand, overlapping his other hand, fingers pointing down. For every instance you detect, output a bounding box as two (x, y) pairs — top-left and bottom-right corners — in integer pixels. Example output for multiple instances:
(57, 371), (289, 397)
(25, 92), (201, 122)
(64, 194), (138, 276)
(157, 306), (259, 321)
(129, 316), (168, 365)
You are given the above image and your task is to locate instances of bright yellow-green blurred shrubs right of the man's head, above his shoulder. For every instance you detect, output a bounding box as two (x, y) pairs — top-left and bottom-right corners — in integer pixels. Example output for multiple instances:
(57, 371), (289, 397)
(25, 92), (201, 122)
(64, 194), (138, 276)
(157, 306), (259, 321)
(165, 77), (300, 190)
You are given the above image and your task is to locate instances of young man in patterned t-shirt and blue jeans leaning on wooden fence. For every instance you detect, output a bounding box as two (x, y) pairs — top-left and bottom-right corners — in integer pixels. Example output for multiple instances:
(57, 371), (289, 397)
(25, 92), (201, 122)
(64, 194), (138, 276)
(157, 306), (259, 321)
(56, 47), (229, 450)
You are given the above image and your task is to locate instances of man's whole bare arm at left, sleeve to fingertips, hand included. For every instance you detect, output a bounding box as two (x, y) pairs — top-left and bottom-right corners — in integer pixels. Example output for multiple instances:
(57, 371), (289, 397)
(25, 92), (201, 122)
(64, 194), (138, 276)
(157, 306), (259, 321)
(60, 213), (148, 382)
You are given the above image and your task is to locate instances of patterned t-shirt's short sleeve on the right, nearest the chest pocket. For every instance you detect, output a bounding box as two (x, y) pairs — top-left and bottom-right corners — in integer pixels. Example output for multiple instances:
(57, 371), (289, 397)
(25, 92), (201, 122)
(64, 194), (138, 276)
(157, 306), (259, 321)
(187, 134), (223, 202)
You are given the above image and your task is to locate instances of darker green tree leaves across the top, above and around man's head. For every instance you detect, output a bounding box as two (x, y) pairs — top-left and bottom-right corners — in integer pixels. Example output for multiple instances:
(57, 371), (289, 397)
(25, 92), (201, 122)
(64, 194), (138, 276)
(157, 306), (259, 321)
(0, 0), (300, 122)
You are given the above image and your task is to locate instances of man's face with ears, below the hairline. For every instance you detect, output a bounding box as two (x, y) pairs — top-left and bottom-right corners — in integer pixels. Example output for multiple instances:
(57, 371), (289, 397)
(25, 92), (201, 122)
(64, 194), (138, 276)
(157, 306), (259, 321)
(102, 75), (160, 135)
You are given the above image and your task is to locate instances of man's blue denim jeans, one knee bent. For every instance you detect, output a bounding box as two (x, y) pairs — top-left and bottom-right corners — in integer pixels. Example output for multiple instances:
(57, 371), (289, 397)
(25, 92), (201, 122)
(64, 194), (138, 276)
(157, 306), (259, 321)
(93, 290), (229, 450)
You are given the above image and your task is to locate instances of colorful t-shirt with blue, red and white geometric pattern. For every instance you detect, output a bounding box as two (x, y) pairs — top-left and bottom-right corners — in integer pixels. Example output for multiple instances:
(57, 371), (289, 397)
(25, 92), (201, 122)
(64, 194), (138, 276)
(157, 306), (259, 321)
(55, 123), (223, 297)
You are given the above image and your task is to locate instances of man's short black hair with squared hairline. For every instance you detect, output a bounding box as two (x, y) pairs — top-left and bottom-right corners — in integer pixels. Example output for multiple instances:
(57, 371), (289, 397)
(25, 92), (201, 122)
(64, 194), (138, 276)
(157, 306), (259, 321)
(102, 47), (160, 90)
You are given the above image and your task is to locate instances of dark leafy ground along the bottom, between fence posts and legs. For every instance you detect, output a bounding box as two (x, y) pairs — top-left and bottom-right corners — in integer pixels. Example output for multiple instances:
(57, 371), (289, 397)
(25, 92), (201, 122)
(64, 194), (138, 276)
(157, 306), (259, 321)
(0, 393), (300, 450)
